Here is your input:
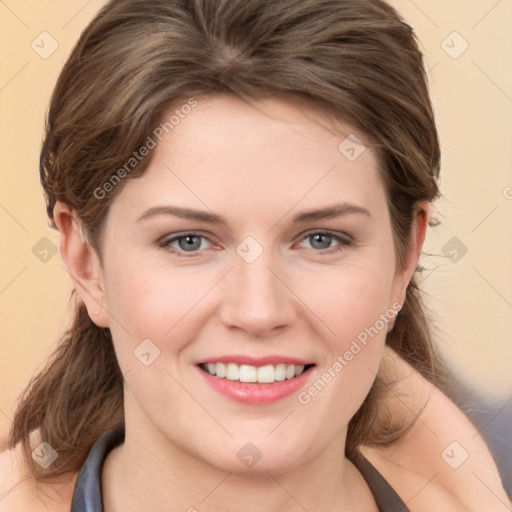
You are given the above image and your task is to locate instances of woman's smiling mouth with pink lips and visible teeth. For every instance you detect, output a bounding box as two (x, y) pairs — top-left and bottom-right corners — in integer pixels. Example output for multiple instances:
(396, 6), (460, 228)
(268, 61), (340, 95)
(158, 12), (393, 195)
(196, 356), (315, 405)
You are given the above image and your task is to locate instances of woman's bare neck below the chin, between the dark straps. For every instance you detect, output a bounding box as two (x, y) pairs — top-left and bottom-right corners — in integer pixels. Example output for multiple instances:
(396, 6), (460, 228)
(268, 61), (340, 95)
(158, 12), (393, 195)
(102, 412), (377, 512)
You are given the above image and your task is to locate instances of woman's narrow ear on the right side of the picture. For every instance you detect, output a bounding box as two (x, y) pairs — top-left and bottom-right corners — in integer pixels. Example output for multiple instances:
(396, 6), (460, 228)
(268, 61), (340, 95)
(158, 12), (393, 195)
(392, 201), (429, 310)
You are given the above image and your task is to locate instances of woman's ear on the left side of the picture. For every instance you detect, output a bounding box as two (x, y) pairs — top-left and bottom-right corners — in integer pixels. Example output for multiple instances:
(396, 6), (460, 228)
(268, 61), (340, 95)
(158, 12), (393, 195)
(53, 201), (109, 327)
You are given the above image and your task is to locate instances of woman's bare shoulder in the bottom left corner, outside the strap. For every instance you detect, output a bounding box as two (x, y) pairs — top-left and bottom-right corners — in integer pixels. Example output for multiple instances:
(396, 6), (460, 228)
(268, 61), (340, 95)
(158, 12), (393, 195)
(0, 445), (77, 512)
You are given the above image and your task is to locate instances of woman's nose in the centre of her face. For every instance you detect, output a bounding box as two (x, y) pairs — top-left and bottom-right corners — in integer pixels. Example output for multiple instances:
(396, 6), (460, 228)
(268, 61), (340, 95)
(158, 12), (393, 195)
(220, 251), (297, 338)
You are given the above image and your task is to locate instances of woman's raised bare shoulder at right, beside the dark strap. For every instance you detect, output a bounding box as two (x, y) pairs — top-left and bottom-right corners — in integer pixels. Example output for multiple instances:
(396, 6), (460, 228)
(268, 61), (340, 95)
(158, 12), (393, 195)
(361, 350), (511, 512)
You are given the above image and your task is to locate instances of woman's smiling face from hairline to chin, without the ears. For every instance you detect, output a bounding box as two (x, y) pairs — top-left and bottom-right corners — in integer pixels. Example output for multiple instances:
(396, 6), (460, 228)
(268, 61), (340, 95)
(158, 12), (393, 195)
(82, 96), (416, 474)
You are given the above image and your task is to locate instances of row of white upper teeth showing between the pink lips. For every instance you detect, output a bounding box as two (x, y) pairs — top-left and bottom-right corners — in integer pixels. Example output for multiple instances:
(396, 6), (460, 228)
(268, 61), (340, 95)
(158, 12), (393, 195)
(202, 363), (304, 384)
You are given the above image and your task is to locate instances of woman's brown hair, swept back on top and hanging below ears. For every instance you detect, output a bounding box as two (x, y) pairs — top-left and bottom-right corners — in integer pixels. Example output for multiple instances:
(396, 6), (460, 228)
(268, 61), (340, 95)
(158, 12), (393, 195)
(9, 0), (448, 481)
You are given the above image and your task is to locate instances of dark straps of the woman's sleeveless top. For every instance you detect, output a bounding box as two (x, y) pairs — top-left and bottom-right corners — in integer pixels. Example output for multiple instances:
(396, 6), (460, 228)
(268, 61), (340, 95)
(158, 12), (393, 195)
(70, 426), (409, 512)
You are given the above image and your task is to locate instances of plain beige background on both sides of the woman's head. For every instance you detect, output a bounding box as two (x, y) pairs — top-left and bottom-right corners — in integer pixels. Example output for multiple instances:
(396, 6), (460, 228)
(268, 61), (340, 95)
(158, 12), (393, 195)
(0, 0), (512, 440)
